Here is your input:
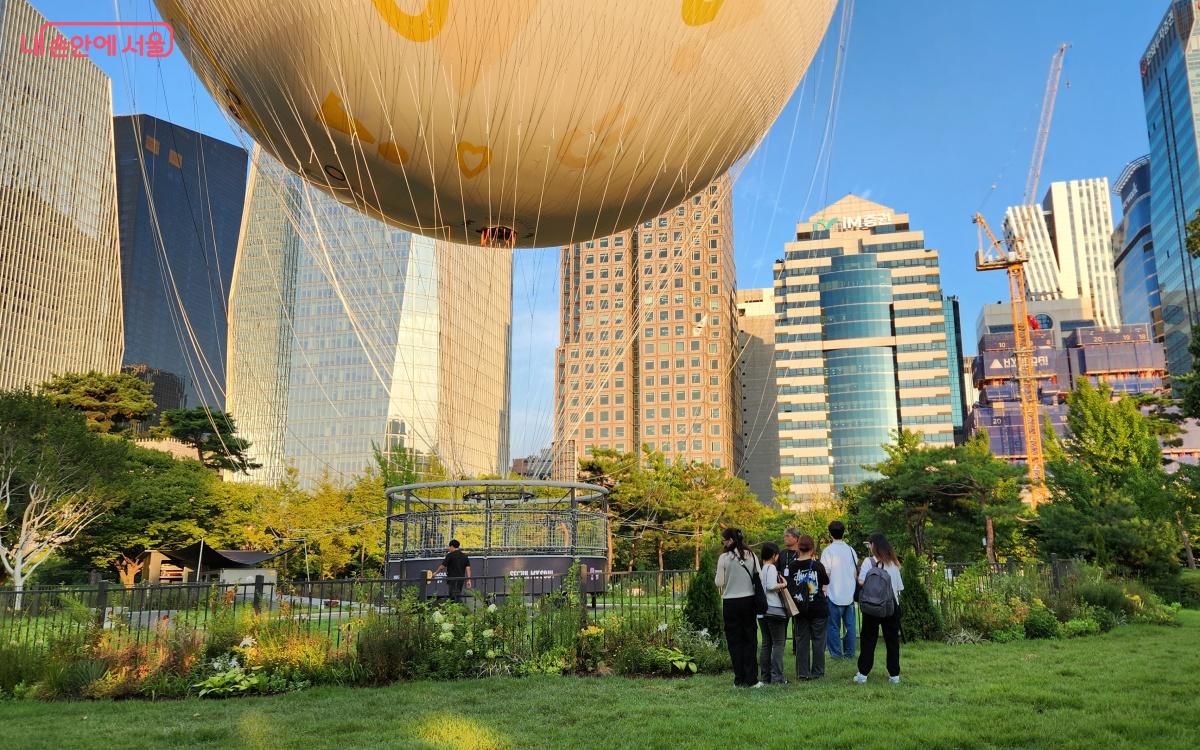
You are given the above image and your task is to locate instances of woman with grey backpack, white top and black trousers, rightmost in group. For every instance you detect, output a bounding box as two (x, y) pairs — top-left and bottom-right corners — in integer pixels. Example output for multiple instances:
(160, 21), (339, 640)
(854, 532), (904, 684)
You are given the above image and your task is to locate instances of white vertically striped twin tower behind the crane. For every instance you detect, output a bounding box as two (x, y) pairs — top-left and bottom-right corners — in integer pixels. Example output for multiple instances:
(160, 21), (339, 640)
(1004, 178), (1121, 325)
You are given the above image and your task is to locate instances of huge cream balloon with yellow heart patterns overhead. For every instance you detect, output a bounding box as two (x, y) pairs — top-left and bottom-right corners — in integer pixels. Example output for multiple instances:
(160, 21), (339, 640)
(156, 0), (836, 246)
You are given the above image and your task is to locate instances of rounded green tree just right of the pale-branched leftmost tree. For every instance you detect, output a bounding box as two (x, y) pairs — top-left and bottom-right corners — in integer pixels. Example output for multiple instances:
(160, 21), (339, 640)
(68, 446), (227, 586)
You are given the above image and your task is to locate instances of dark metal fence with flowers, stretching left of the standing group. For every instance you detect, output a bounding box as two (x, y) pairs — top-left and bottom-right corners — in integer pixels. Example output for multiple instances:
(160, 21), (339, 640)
(0, 570), (695, 653)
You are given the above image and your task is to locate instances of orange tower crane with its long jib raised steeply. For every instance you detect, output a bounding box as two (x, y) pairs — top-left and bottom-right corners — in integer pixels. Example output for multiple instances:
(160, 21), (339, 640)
(973, 44), (1068, 509)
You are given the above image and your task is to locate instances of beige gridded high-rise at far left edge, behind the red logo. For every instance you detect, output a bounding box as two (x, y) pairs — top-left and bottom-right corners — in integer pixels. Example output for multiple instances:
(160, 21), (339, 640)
(0, 0), (122, 389)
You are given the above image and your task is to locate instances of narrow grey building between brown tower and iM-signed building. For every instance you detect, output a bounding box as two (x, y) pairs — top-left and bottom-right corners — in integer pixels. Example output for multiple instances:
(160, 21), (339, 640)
(738, 287), (780, 504)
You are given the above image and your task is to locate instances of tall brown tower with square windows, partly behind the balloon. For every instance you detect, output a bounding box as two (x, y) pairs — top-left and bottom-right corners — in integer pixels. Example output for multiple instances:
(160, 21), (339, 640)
(553, 176), (740, 479)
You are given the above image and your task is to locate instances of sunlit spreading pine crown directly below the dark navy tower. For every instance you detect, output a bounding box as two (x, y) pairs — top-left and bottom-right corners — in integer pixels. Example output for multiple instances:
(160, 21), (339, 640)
(38, 370), (155, 432)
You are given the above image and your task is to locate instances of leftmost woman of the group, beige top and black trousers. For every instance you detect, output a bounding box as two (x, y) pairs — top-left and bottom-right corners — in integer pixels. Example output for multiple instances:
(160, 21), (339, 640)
(715, 528), (762, 688)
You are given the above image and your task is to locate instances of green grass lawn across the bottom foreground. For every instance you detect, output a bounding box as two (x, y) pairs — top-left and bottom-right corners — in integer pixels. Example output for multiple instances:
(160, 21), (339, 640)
(0, 612), (1200, 750)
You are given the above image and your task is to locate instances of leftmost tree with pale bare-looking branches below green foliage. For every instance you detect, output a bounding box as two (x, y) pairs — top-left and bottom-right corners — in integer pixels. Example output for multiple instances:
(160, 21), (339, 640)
(0, 391), (130, 608)
